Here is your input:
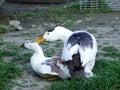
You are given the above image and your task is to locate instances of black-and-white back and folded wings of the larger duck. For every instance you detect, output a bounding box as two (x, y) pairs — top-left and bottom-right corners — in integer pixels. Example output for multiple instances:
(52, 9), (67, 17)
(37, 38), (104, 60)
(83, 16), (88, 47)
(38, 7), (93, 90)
(62, 32), (94, 66)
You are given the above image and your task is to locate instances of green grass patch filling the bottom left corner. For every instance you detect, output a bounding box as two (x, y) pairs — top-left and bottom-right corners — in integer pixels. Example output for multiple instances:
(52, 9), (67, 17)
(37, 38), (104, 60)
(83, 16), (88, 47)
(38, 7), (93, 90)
(0, 58), (22, 90)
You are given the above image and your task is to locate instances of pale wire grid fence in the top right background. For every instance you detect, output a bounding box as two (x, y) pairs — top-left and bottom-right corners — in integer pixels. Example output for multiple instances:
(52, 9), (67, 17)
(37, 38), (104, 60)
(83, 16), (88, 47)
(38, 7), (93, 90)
(79, 0), (120, 10)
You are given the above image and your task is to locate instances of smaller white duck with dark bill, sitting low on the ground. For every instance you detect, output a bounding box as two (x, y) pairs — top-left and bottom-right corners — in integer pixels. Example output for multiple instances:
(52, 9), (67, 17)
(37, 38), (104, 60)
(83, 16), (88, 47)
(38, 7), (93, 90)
(21, 41), (70, 78)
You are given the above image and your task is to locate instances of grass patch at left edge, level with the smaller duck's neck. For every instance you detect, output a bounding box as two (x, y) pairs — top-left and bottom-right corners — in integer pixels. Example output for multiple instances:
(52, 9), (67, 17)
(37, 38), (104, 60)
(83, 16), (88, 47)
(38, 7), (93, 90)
(0, 41), (32, 64)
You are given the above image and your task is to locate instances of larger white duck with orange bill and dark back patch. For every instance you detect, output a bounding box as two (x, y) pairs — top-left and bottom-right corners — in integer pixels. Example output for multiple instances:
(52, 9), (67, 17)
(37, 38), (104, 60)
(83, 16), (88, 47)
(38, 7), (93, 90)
(36, 26), (97, 78)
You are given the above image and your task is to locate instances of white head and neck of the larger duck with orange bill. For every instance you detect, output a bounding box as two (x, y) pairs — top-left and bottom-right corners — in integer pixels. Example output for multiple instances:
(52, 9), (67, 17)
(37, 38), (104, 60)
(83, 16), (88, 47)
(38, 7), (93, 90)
(35, 26), (72, 44)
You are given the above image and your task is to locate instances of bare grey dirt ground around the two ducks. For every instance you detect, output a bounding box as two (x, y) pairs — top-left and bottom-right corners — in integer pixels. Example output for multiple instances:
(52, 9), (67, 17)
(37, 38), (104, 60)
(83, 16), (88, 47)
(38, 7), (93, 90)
(0, 0), (120, 90)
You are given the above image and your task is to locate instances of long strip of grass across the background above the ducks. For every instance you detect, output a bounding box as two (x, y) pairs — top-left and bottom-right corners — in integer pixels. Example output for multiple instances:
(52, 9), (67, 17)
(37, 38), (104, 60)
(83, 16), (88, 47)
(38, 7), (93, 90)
(13, 2), (111, 26)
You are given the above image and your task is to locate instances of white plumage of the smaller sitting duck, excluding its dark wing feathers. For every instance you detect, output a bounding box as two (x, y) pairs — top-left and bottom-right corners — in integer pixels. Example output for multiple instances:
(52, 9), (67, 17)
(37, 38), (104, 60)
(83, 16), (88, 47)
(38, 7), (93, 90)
(24, 41), (70, 78)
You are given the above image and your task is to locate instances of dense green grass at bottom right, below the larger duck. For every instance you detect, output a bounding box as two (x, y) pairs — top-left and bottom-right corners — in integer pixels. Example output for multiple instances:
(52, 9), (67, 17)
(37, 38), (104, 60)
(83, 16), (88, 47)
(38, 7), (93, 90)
(49, 60), (120, 90)
